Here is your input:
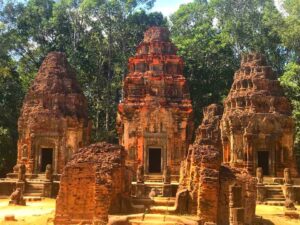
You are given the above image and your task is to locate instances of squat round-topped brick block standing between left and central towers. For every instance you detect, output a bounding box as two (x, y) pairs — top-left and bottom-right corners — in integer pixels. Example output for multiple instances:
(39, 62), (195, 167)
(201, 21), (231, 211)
(54, 142), (130, 225)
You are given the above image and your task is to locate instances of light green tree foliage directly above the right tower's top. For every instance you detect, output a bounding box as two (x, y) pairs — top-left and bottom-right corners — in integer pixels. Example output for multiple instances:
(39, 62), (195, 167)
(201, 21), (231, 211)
(210, 0), (286, 74)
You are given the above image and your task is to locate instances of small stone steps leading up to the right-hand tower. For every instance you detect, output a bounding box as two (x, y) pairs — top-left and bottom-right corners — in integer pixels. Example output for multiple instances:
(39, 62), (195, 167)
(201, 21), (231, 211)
(265, 185), (285, 206)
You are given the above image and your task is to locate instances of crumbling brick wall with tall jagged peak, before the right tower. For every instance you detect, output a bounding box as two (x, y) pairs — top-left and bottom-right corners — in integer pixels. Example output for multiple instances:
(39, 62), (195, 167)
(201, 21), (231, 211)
(179, 104), (256, 225)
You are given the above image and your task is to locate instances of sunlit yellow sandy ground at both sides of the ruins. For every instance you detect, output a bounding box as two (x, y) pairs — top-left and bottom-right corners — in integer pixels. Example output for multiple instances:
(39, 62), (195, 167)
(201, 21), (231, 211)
(0, 199), (300, 225)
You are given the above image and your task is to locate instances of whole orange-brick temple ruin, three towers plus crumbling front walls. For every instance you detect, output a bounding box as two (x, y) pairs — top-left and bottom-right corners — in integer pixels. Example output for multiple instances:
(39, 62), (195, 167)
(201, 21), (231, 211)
(0, 27), (300, 225)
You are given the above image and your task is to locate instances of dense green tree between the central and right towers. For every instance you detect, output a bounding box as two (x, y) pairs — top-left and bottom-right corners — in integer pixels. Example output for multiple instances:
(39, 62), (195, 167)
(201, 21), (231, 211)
(171, 1), (237, 122)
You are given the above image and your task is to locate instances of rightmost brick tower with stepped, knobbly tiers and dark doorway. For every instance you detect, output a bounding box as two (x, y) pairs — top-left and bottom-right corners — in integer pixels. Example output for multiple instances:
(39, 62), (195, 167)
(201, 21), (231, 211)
(221, 53), (298, 177)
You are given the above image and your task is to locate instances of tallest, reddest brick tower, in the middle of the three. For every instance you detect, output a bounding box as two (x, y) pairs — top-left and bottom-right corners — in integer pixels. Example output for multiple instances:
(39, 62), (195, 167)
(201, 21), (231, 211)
(117, 27), (193, 177)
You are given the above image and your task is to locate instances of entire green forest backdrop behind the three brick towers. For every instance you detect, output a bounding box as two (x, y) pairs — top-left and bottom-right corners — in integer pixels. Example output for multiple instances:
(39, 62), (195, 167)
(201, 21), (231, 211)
(0, 0), (300, 175)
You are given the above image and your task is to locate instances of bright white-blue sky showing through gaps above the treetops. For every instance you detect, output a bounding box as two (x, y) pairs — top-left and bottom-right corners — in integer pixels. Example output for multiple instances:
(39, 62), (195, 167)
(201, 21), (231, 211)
(151, 0), (282, 16)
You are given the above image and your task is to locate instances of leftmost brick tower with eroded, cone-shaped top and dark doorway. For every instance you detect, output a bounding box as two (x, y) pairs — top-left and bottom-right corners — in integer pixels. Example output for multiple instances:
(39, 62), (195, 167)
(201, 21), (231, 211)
(17, 52), (89, 174)
